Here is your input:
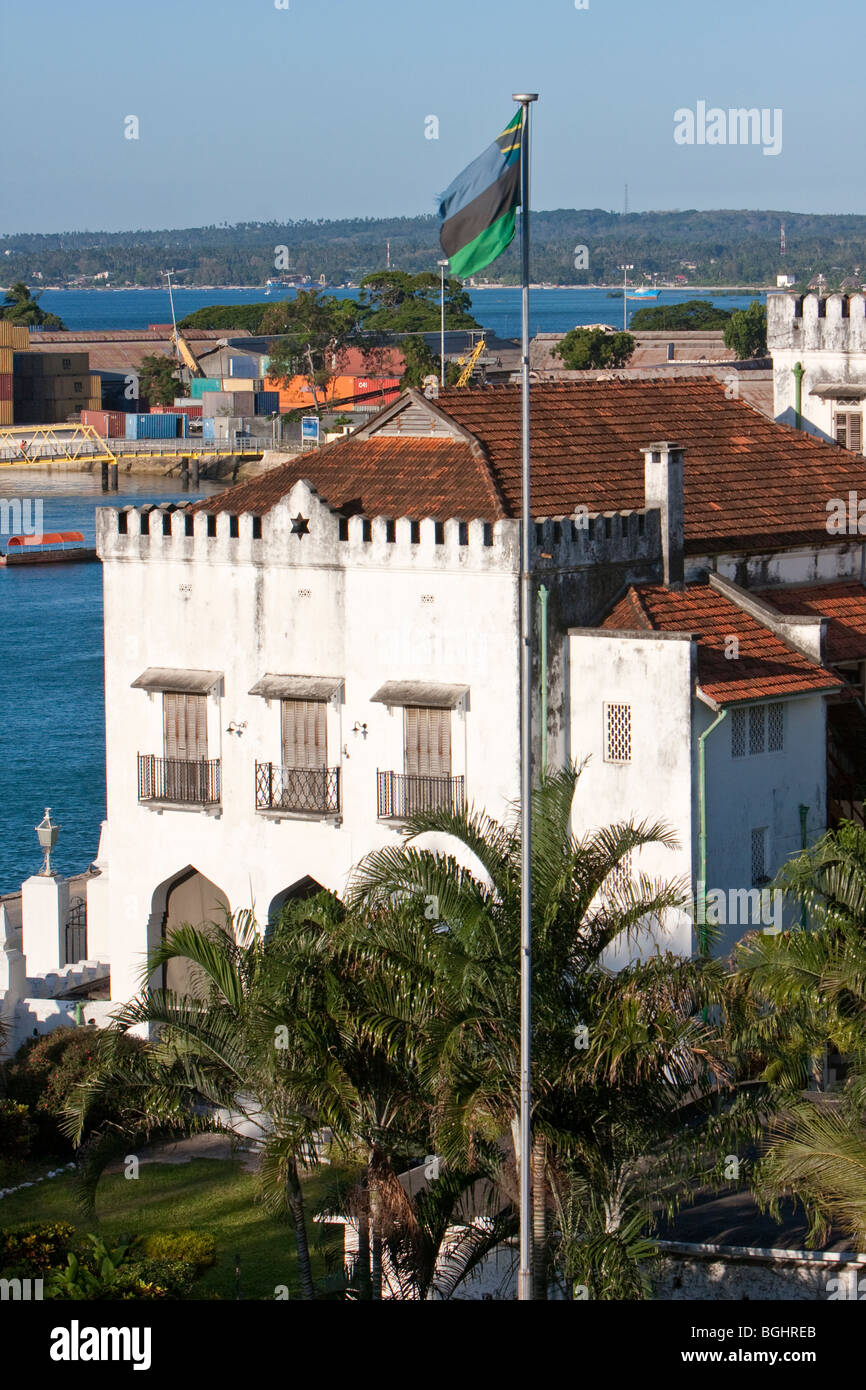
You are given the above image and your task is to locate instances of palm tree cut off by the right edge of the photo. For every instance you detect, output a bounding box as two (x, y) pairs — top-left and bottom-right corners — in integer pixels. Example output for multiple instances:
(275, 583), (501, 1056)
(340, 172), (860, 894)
(737, 821), (866, 1248)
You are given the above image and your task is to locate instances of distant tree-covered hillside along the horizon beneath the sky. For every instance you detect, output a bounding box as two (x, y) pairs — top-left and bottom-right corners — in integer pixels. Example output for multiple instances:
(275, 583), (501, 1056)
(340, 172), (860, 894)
(0, 209), (866, 286)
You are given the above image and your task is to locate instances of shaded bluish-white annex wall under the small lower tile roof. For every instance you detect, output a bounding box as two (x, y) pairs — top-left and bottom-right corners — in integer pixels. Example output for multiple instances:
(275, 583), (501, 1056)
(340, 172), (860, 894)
(692, 695), (827, 955)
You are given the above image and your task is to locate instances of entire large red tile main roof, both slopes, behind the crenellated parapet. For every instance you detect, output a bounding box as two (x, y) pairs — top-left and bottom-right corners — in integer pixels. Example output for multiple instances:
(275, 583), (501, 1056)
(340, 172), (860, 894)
(193, 378), (866, 555)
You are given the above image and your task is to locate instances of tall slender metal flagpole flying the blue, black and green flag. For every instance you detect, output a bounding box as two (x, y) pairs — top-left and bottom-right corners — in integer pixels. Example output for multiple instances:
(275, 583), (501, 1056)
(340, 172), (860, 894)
(514, 92), (538, 1300)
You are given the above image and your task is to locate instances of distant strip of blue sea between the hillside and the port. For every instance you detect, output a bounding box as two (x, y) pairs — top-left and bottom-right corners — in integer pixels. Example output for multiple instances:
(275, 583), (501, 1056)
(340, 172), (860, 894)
(32, 280), (766, 338)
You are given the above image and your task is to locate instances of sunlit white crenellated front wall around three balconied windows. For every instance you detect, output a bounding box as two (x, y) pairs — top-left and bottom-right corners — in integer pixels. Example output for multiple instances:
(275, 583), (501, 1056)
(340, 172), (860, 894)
(99, 484), (518, 999)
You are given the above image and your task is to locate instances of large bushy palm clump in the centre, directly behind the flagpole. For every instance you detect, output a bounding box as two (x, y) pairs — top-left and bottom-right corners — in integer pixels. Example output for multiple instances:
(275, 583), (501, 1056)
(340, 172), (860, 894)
(346, 767), (727, 1297)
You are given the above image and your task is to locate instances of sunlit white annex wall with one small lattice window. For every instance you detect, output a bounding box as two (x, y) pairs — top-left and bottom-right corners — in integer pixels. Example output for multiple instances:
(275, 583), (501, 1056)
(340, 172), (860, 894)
(569, 630), (692, 966)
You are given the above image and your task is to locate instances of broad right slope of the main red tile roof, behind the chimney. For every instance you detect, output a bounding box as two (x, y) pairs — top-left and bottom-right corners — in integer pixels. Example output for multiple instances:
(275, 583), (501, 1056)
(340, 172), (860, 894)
(438, 378), (866, 555)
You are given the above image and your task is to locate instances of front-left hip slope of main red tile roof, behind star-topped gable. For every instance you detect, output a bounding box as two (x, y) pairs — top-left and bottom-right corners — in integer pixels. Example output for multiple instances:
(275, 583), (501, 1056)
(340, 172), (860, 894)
(195, 436), (506, 521)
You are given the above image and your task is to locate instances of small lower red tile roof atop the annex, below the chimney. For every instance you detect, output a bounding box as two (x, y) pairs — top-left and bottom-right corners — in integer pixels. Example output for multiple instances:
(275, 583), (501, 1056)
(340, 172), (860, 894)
(602, 584), (844, 705)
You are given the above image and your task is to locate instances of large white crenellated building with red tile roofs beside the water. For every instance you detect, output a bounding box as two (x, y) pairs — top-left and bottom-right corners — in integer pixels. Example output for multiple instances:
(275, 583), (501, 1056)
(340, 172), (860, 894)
(6, 381), (866, 1045)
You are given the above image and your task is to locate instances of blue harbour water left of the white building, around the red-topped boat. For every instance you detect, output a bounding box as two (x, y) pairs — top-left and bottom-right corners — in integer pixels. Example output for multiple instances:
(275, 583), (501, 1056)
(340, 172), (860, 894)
(0, 468), (220, 892)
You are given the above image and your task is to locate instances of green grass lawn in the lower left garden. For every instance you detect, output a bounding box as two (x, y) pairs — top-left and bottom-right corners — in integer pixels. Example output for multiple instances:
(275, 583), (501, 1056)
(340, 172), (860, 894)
(0, 1158), (342, 1298)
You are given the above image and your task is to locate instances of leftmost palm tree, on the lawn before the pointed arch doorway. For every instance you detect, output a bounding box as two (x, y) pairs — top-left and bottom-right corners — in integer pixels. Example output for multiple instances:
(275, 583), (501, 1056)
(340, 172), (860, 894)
(65, 912), (320, 1300)
